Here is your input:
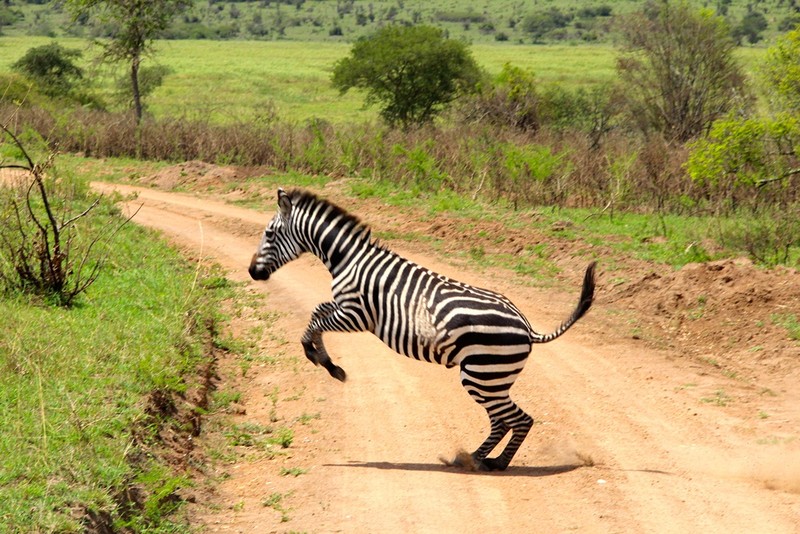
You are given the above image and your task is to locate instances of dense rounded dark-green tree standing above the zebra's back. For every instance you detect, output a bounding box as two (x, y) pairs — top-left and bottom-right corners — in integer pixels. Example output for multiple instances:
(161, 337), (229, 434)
(332, 25), (482, 128)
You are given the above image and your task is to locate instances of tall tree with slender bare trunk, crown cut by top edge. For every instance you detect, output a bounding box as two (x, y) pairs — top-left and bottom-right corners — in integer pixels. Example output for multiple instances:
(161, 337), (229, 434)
(66, 0), (193, 122)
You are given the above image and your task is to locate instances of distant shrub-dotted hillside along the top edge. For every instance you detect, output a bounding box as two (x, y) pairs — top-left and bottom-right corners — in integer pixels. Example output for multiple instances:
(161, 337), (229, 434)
(0, 0), (800, 44)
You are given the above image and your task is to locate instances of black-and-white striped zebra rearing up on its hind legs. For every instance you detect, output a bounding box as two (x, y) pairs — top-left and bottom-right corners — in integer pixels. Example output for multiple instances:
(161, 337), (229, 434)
(249, 189), (596, 471)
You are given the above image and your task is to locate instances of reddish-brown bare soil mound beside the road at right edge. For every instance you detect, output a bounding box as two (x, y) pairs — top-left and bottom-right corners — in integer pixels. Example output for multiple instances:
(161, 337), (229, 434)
(608, 258), (800, 372)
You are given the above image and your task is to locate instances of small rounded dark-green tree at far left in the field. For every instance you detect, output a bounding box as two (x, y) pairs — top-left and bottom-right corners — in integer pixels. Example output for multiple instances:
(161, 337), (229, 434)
(11, 42), (83, 97)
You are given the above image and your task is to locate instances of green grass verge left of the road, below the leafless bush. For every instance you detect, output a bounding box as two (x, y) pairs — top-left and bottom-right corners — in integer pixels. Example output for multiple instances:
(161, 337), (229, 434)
(0, 201), (225, 532)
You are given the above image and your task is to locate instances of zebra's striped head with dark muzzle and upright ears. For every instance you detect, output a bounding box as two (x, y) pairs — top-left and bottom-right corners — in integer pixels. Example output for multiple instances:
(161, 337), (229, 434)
(248, 189), (303, 280)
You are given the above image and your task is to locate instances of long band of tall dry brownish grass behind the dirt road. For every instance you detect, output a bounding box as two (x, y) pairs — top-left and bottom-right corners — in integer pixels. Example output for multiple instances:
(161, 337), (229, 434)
(0, 102), (800, 213)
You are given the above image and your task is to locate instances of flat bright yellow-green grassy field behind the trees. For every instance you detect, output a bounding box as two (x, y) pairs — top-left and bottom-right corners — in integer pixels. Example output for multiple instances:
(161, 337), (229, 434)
(0, 37), (764, 123)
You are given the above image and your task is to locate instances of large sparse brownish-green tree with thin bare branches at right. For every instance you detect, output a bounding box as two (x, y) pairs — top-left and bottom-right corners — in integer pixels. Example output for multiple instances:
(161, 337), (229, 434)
(617, 0), (750, 141)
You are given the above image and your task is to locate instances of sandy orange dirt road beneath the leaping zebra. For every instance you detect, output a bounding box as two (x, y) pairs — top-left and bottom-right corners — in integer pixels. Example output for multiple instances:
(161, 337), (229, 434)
(95, 184), (800, 534)
